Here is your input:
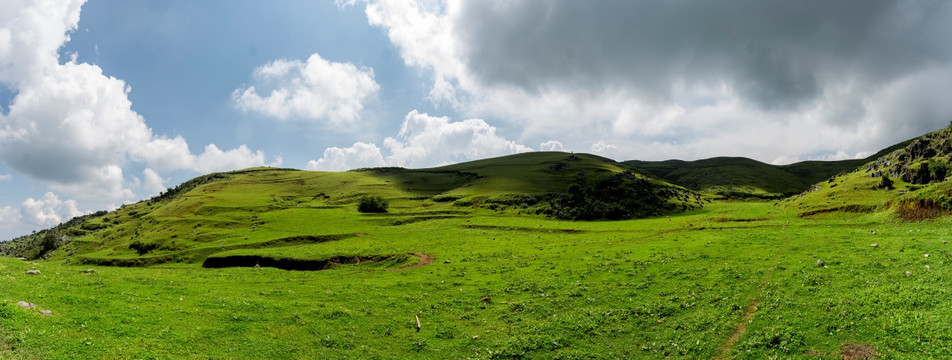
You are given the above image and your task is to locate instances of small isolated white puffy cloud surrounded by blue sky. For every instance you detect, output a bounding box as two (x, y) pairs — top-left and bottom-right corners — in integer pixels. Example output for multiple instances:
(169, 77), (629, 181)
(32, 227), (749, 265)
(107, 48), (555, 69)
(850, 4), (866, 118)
(232, 54), (380, 125)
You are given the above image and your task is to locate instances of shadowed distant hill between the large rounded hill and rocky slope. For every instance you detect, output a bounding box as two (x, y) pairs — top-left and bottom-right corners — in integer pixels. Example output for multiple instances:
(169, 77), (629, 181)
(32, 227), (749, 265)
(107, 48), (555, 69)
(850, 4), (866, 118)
(624, 144), (901, 198)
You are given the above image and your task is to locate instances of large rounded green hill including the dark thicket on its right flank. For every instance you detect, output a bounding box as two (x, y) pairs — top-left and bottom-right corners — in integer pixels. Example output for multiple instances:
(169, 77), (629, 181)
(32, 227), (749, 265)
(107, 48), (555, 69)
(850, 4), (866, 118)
(0, 152), (703, 266)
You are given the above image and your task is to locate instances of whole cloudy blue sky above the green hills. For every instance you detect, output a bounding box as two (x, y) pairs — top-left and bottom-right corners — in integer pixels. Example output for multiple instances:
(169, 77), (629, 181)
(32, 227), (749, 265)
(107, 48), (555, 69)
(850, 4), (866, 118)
(0, 0), (952, 240)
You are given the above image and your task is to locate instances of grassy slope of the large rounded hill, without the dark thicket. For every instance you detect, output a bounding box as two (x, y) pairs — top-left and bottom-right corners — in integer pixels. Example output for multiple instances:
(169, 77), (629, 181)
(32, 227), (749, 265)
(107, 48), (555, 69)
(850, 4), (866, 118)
(0, 152), (700, 266)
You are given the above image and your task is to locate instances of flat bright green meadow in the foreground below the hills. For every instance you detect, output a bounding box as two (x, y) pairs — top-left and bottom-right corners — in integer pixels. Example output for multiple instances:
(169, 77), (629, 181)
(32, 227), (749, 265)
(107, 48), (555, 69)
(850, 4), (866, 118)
(0, 201), (952, 359)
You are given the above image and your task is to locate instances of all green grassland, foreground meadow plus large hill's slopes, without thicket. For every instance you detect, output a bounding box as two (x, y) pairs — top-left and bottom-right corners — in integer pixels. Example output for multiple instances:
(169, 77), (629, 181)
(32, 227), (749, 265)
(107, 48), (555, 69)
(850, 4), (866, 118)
(0, 142), (952, 359)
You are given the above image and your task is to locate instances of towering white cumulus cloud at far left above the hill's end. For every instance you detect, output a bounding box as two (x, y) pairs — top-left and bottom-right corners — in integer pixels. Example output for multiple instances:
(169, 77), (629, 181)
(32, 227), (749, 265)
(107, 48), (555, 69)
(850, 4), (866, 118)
(0, 0), (278, 202)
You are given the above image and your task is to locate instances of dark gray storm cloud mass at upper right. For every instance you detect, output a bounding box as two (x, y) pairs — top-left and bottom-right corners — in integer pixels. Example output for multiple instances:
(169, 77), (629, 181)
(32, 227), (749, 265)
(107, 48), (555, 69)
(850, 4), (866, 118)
(453, 0), (952, 111)
